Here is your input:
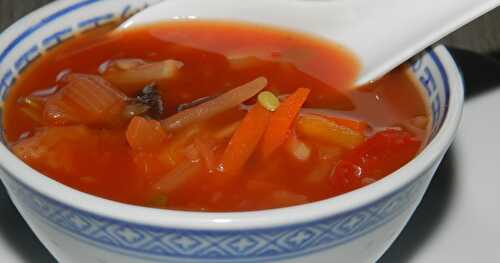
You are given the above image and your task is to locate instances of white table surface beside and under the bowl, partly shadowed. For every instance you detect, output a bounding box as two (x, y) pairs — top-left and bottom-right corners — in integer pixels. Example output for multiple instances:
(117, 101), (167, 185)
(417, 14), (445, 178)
(0, 52), (500, 263)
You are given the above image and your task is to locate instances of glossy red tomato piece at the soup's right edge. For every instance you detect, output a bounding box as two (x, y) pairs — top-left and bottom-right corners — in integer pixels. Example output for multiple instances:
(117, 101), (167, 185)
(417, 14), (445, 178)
(330, 129), (422, 194)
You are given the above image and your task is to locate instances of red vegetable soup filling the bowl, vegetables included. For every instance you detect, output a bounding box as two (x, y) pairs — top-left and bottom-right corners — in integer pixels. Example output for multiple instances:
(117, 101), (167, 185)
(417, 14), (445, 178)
(4, 21), (429, 211)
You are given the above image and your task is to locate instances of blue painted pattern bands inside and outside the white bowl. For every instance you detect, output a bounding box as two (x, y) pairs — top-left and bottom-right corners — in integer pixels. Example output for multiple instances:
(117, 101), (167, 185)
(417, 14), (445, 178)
(0, 0), (450, 262)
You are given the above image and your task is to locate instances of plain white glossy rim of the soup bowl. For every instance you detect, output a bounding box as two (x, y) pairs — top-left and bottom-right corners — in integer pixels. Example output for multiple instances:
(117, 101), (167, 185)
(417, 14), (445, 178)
(0, 0), (464, 231)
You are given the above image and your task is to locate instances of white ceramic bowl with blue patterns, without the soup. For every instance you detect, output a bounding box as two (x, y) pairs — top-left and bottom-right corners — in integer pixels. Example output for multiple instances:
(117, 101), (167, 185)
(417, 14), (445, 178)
(0, 0), (464, 263)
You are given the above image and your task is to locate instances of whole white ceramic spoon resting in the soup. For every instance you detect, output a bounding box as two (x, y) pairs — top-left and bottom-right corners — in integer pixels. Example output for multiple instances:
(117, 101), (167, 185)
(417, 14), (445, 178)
(117, 0), (500, 86)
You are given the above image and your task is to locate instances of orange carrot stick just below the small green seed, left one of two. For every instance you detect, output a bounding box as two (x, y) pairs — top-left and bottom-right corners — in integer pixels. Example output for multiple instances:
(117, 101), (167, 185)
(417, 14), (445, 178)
(221, 103), (271, 178)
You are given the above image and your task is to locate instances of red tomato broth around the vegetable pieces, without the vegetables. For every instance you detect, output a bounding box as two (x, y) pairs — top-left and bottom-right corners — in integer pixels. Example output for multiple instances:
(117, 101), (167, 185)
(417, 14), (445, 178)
(4, 21), (428, 211)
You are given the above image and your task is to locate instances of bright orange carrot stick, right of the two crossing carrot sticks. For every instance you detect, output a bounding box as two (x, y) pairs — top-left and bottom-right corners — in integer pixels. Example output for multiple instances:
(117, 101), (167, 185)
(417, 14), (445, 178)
(261, 88), (310, 158)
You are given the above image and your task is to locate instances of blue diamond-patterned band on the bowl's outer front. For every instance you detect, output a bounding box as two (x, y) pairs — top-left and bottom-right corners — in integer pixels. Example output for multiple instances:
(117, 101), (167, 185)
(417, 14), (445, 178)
(4, 172), (424, 262)
